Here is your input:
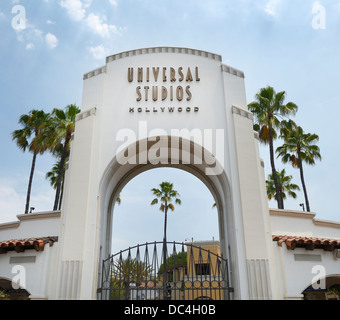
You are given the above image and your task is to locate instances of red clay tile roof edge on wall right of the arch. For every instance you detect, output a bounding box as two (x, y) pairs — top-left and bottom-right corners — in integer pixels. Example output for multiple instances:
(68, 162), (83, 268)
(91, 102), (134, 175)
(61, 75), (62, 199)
(273, 235), (340, 251)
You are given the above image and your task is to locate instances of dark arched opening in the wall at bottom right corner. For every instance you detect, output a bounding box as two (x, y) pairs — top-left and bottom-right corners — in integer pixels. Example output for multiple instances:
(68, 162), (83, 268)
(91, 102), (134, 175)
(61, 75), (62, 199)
(302, 275), (340, 300)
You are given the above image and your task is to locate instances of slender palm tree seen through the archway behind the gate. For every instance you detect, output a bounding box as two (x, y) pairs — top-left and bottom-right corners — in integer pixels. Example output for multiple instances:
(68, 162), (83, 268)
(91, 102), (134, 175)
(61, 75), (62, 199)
(151, 182), (182, 299)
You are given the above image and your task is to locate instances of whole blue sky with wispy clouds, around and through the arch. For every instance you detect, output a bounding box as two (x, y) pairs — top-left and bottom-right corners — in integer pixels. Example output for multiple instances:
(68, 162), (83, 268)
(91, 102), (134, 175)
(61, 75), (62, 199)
(0, 0), (340, 252)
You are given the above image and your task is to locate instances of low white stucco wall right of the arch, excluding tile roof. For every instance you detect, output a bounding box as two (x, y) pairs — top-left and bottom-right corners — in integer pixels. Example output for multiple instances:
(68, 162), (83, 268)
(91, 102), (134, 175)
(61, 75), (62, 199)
(270, 210), (340, 299)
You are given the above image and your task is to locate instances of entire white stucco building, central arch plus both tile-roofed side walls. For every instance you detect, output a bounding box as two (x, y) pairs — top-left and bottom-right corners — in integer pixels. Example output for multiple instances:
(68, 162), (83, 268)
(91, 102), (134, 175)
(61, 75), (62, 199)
(0, 47), (340, 300)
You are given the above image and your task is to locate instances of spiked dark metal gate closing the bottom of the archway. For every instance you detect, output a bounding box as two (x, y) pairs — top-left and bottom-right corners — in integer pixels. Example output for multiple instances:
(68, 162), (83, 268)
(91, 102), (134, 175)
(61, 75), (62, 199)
(98, 242), (233, 300)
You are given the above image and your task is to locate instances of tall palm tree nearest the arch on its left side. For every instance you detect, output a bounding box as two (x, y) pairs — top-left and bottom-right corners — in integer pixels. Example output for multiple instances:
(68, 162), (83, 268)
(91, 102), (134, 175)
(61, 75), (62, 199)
(48, 104), (80, 211)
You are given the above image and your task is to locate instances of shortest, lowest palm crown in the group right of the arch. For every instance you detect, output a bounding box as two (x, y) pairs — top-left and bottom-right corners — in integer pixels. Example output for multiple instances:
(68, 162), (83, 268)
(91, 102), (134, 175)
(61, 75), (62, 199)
(266, 169), (300, 205)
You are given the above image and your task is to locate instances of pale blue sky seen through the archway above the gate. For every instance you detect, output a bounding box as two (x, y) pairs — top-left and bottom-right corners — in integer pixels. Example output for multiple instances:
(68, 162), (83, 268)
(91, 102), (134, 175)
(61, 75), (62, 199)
(111, 168), (220, 254)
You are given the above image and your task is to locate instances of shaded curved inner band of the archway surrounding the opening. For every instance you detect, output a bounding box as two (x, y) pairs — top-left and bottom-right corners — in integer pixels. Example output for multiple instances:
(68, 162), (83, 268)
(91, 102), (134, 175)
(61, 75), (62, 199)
(98, 136), (238, 296)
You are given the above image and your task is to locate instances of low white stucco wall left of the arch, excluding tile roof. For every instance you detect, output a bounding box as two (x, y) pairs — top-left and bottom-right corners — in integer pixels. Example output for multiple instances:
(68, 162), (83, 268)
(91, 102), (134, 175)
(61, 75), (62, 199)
(0, 212), (60, 299)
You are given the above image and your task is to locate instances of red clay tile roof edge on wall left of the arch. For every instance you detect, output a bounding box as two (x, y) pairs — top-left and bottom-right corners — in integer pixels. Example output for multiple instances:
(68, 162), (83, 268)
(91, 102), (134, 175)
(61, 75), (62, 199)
(0, 237), (58, 254)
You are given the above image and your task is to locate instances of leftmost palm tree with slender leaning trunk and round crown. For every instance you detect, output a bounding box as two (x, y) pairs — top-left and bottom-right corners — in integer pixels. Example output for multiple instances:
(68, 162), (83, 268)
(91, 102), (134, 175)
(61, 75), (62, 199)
(12, 110), (50, 214)
